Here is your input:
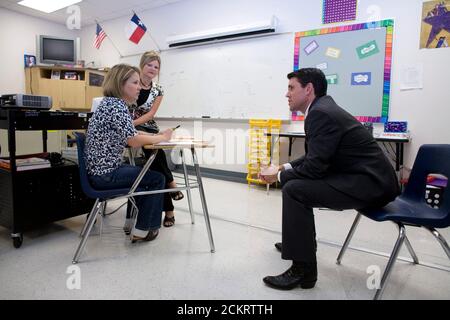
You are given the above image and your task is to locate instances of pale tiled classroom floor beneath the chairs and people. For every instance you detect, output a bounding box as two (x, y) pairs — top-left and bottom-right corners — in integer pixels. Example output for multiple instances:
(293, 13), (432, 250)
(0, 175), (450, 299)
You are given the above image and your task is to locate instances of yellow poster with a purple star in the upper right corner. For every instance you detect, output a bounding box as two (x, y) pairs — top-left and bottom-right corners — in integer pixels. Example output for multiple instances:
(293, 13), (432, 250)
(420, 0), (450, 49)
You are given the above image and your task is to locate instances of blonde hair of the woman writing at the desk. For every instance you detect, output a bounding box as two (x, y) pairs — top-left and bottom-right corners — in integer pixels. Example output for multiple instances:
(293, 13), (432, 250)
(103, 63), (139, 99)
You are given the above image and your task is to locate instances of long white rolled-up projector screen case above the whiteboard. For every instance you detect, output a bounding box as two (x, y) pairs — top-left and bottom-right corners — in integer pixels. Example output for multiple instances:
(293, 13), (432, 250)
(166, 16), (277, 48)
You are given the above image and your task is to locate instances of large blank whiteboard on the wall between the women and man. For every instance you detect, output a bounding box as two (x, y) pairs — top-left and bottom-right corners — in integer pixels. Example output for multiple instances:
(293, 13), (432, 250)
(158, 33), (294, 120)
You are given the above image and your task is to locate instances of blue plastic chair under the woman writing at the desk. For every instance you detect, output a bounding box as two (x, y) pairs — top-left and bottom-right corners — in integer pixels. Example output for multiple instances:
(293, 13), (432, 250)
(72, 132), (137, 264)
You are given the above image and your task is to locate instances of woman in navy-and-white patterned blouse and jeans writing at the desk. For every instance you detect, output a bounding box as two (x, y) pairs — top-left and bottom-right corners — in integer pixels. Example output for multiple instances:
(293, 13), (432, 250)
(85, 64), (172, 242)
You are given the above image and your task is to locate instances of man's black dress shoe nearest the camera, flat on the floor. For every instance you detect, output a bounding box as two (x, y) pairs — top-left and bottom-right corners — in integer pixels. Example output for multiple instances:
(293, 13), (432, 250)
(263, 264), (317, 290)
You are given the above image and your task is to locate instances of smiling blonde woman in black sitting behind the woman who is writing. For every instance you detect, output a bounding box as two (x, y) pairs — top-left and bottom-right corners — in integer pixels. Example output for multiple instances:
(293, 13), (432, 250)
(129, 51), (184, 227)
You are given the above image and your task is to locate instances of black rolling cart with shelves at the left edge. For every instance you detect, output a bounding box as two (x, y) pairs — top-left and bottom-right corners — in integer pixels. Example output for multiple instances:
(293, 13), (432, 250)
(0, 107), (94, 248)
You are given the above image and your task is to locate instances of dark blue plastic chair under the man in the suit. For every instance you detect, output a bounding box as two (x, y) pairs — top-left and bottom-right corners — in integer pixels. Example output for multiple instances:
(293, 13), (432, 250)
(337, 144), (450, 300)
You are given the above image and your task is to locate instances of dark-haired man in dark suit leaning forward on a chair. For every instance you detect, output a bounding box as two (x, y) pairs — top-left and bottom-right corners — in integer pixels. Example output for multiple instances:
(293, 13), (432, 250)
(262, 68), (399, 290)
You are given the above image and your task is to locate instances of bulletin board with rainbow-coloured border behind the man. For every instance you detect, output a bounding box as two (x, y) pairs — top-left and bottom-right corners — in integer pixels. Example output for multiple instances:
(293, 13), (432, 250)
(292, 20), (394, 122)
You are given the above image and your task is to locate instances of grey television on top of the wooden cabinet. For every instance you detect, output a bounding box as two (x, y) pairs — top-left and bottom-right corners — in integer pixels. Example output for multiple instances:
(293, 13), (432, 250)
(39, 36), (77, 64)
